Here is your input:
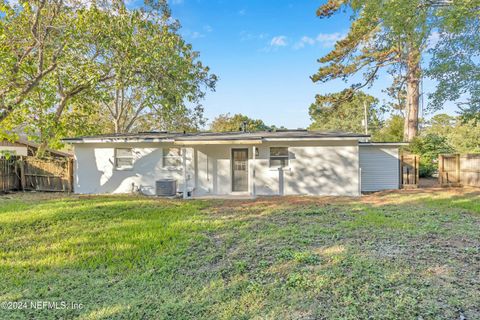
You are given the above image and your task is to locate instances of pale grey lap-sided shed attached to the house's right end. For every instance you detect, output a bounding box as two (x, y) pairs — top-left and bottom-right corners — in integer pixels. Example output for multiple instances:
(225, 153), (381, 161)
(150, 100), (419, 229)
(359, 145), (400, 192)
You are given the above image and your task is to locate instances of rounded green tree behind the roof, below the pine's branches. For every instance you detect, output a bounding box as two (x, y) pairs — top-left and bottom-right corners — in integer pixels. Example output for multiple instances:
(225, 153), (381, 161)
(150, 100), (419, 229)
(309, 90), (382, 133)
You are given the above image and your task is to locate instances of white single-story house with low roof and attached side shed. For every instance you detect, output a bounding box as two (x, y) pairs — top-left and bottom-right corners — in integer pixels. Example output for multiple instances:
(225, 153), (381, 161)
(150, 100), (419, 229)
(64, 130), (402, 197)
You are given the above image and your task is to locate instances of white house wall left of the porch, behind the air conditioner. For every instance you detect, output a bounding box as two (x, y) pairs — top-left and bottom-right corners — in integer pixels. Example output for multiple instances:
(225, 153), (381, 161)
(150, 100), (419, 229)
(74, 143), (194, 195)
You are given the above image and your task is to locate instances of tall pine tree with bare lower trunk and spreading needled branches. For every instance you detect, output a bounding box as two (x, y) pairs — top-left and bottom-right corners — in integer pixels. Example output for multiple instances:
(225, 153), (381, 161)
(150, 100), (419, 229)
(312, 0), (444, 141)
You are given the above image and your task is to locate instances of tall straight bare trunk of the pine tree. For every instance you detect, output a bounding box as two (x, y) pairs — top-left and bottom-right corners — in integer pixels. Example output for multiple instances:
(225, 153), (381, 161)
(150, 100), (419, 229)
(403, 48), (421, 142)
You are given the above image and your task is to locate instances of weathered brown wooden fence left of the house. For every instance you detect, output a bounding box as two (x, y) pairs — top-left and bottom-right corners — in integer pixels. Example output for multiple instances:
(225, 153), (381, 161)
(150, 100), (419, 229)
(0, 157), (73, 192)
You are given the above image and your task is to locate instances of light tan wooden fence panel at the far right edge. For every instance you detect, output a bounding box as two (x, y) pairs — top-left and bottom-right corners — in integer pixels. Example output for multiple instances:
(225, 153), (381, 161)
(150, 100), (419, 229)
(438, 154), (480, 187)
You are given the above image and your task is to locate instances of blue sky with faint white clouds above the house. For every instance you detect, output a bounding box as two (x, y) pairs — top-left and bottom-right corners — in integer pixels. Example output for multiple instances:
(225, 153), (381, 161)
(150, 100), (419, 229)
(166, 0), (453, 128)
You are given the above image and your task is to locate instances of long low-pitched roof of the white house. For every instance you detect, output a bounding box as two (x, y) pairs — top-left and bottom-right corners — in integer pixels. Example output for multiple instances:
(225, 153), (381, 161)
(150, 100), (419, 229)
(63, 130), (370, 144)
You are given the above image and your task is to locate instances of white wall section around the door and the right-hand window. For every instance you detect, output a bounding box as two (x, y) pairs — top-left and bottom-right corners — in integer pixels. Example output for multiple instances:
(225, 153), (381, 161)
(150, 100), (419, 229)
(194, 140), (359, 196)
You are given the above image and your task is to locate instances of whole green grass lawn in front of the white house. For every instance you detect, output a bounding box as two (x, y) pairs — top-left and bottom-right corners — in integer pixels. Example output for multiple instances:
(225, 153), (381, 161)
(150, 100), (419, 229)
(0, 189), (480, 319)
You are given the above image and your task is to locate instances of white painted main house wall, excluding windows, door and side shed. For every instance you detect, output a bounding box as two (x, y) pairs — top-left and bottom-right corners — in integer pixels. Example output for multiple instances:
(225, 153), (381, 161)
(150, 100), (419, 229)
(75, 140), (359, 196)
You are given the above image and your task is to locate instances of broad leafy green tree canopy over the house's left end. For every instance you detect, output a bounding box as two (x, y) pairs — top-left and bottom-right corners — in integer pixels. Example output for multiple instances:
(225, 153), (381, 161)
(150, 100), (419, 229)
(0, 0), (216, 155)
